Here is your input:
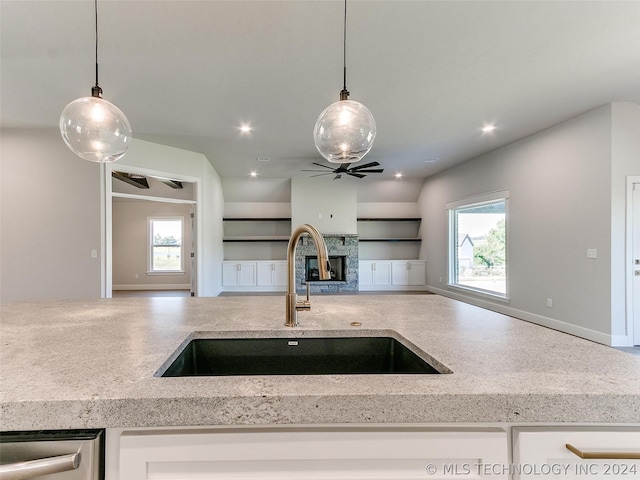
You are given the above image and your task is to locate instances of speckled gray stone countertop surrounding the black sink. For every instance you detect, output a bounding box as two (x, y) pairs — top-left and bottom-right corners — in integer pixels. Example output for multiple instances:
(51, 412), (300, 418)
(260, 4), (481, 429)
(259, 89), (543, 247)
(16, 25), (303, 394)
(0, 295), (640, 430)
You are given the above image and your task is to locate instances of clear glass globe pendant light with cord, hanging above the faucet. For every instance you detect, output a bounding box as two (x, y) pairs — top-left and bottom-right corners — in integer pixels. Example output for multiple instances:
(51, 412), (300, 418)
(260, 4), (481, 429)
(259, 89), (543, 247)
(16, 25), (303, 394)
(313, 0), (376, 163)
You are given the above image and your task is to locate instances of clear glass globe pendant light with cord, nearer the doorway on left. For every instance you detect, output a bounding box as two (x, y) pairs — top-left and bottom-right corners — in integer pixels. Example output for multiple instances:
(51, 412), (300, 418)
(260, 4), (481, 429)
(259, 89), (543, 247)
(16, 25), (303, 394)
(60, 0), (131, 163)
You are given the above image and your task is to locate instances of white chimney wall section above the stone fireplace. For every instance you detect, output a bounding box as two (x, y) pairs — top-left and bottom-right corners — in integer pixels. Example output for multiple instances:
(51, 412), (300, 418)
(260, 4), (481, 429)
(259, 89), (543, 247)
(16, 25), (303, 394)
(291, 177), (358, 234)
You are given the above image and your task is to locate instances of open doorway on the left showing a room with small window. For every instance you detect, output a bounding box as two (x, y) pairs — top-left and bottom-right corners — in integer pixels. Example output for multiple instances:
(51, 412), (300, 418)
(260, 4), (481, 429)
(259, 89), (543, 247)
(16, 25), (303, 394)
(103, 165), (198, 298)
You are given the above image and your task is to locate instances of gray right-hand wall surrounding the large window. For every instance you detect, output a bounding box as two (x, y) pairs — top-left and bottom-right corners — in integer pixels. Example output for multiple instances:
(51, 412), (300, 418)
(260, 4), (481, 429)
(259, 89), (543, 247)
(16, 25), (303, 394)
(419, 104), (640, 344)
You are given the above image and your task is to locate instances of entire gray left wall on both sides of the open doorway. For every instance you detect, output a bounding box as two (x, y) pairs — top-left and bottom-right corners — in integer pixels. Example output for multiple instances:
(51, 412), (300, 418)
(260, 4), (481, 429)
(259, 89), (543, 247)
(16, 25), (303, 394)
(0, 129), (224, 302)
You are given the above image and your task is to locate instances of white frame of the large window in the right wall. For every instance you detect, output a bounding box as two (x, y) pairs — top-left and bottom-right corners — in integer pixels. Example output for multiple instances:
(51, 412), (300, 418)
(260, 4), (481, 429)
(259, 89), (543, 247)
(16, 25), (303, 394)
(446, 190), (510, 303)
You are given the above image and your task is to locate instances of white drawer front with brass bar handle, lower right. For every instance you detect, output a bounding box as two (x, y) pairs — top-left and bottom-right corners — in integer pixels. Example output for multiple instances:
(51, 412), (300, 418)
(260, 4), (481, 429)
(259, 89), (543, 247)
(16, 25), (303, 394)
(511, 427), (640, 480)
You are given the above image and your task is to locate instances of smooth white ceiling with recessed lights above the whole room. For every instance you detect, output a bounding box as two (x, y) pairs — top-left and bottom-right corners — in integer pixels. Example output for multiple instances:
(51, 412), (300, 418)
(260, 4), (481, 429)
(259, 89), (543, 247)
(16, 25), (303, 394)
(0, 0), (640, 182)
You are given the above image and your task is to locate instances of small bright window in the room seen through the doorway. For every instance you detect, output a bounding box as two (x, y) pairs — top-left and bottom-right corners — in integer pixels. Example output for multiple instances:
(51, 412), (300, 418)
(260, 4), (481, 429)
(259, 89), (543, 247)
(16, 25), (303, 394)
(149, 217), (184, 273)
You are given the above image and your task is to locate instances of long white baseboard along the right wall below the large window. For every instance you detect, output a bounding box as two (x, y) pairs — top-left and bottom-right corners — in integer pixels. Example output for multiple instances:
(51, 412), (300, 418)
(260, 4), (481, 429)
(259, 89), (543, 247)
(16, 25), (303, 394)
(427, 285), (614, 346)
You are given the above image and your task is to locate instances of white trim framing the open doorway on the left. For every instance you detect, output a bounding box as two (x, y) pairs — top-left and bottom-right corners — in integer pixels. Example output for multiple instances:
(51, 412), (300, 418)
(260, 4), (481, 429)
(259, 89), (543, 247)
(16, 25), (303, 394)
(100, 163), (202, 298)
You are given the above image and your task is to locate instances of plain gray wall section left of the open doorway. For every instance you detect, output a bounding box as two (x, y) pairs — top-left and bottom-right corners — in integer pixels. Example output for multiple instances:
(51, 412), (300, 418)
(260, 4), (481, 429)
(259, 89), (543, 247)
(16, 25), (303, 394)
(0, 129), (100, 302)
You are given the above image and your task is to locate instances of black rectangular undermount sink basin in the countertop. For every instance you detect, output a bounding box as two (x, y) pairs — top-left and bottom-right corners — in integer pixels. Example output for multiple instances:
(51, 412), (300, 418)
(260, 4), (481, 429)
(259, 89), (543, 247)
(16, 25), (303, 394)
(161, 337), (441, 377)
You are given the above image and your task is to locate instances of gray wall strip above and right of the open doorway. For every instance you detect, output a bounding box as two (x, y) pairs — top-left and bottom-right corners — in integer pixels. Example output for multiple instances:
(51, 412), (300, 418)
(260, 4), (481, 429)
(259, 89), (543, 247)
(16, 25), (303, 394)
(118, 139), (224, 297)
